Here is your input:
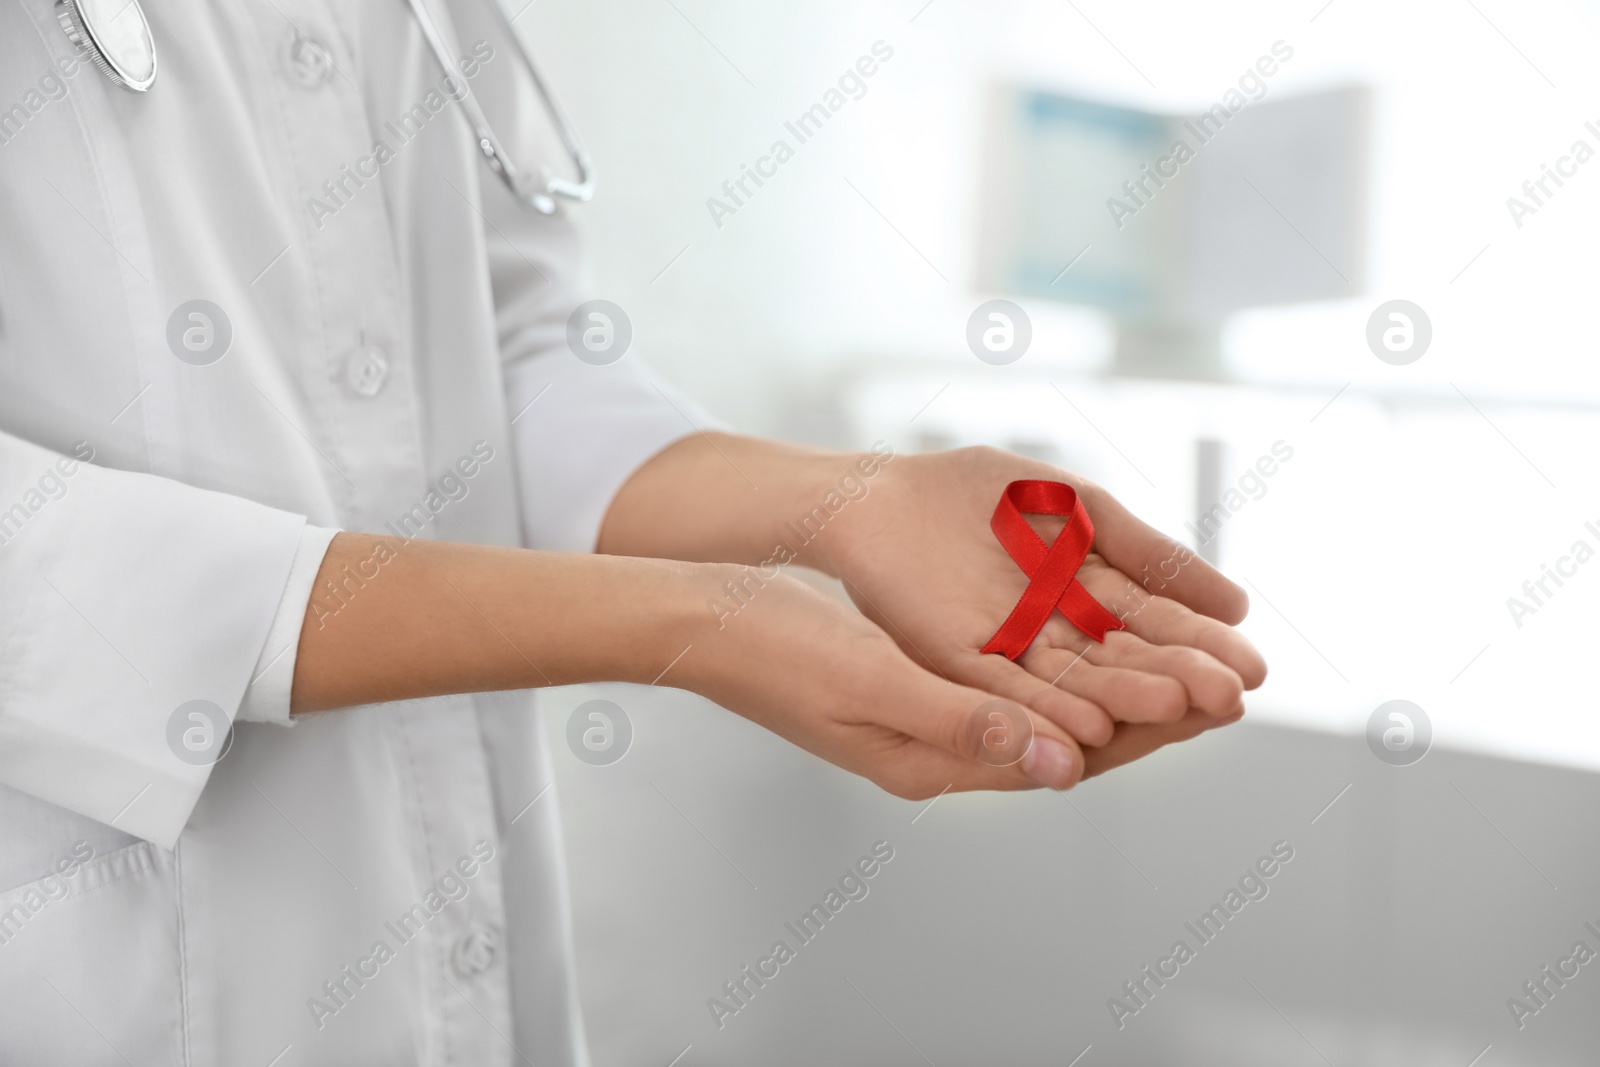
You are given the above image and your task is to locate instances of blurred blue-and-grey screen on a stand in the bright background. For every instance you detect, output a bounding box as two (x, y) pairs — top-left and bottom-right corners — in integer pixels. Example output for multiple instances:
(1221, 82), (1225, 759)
(978, 86), (1370, 378)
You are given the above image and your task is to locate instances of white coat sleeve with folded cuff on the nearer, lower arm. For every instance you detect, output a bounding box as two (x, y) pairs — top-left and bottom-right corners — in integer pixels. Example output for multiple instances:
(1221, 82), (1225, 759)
(0, 434), (306, 848)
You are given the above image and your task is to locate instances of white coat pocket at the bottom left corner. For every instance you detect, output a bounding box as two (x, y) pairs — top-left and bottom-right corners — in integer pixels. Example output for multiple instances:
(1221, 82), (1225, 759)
(0, 841), (184, 1067)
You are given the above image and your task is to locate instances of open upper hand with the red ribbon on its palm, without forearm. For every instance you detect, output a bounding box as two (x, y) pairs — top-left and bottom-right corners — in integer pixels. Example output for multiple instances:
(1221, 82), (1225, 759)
(819, 448), (1267, 751)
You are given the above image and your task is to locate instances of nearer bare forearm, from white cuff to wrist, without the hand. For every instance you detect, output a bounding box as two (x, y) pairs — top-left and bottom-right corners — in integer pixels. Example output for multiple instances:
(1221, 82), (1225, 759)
(291, 533), (722, 712)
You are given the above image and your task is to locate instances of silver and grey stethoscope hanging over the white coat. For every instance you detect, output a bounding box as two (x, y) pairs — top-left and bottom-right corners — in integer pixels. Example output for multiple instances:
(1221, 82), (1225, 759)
(56, 0), (595, 214)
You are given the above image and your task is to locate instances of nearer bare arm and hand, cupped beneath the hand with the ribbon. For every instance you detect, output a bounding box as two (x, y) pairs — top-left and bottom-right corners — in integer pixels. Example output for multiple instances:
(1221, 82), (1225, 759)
(293, 534), (1083, 797)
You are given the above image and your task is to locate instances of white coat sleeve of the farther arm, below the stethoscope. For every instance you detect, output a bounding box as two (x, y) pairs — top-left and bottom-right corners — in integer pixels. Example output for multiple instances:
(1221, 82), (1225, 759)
(480, 171), (725, 552)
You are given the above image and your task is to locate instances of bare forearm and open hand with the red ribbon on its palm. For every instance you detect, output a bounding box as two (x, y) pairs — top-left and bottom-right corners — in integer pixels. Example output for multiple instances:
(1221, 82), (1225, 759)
(598, 434), (1266, 735)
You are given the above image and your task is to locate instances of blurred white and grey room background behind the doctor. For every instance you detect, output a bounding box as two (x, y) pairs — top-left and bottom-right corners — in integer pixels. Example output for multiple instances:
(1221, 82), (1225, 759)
(509, 0), (1600, 1067)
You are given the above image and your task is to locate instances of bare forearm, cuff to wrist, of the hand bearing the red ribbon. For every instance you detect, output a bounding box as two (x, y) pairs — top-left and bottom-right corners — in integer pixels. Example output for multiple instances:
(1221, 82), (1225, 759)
(597, 434), (893, 574)
